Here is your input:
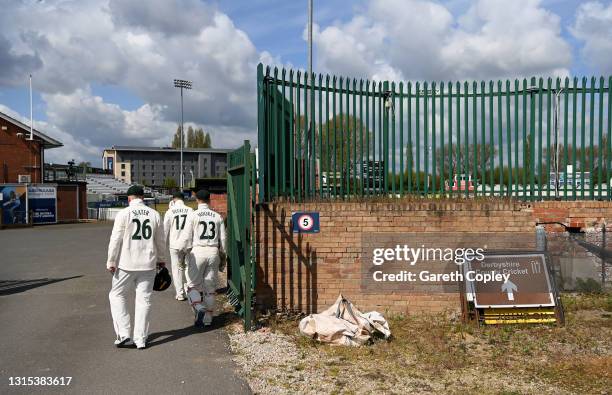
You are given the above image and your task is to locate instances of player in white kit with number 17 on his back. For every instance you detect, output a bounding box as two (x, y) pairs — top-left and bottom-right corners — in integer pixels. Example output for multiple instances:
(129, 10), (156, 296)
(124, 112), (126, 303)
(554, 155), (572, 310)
(164, 192), (193, 300)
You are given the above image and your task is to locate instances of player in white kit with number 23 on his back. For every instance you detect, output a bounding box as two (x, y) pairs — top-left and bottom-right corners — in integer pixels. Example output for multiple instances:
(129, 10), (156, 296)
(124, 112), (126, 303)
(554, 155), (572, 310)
(186, 190), (226, 327)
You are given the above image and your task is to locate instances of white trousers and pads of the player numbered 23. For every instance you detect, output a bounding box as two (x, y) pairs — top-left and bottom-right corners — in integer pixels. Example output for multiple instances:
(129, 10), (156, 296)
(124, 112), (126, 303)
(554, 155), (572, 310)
(185, 247), (220, 320)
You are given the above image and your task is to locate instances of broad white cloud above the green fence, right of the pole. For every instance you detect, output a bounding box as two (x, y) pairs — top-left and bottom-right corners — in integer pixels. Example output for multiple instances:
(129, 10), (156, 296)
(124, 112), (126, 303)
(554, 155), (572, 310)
(315, 0), (572, 80)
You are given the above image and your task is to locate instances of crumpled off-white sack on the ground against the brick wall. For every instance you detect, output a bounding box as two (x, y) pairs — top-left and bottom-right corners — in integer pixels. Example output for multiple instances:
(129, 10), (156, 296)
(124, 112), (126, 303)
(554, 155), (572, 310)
(299, 294), (391, 346)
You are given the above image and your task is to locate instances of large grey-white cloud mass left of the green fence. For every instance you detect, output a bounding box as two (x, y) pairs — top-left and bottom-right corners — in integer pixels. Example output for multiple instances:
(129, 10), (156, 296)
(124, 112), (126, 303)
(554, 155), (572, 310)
(0, 0), (260, 164)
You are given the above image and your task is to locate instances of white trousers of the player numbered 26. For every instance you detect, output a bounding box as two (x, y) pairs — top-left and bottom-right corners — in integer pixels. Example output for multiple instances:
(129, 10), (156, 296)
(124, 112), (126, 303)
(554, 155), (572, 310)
(108, 269), (156, 344)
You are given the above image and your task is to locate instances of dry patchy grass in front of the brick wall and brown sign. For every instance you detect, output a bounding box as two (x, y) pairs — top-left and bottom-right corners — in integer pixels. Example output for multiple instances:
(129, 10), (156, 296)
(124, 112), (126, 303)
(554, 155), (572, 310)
(260, 294), (612, 394)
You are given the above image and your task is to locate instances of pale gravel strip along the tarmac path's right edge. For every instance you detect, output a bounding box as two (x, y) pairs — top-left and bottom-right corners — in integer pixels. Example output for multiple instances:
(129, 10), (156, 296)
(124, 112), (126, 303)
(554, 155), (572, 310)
(230, 328), (568, 394)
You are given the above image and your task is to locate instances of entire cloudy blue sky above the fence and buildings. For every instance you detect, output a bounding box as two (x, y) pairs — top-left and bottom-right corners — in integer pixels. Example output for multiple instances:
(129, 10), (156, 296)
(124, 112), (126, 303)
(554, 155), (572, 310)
(0, 0), (612, 164)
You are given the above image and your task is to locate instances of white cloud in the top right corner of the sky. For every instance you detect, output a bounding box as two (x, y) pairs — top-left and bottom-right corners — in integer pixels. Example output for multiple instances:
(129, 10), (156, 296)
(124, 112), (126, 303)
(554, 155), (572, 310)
(571, 1), (612, 75)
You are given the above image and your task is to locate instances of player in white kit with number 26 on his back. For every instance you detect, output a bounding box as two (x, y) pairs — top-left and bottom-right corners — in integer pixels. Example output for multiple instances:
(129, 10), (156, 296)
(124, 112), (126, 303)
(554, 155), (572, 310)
(106, 185), (166, 349)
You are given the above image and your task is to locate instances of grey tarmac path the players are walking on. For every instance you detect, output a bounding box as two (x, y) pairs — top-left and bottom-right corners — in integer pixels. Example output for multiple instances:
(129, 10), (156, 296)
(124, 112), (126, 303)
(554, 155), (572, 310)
(0, 223), (250, 394)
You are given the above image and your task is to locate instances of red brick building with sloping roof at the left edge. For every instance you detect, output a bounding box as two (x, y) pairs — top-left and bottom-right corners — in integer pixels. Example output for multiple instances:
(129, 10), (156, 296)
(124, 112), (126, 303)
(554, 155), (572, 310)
(0, 112), (63, 183)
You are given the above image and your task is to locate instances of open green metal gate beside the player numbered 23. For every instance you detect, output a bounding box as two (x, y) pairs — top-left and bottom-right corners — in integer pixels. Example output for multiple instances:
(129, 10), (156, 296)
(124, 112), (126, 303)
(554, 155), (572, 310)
(227, 141), (256, 330)
